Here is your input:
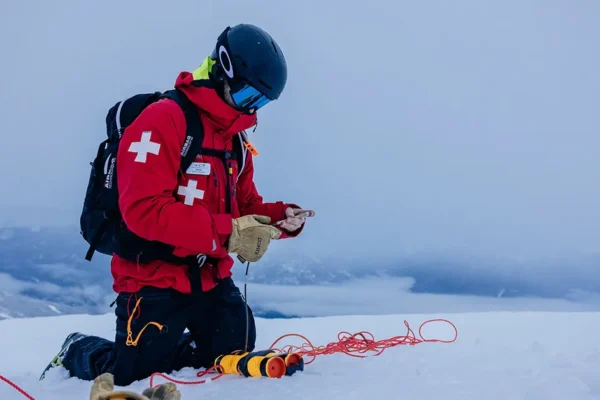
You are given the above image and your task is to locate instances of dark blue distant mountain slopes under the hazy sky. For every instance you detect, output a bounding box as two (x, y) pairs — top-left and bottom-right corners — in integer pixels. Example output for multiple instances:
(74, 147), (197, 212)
(0, 227), (600, 319)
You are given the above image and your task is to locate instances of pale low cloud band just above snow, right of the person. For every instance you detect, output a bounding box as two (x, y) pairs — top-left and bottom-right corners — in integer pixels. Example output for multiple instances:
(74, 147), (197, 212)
(243, 278), (600, 317)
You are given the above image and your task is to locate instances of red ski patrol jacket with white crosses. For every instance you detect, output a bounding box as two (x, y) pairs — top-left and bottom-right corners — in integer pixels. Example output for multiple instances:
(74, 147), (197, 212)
(111, 72), (300, 293)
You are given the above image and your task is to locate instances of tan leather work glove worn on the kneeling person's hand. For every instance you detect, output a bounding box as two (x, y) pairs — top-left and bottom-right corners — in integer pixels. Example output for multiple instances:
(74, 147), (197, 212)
(227, 215), (281, 262)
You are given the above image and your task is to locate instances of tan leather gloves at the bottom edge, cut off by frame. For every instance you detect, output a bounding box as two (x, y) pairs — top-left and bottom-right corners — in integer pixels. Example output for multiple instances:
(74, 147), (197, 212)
(90, 373), (181, 400)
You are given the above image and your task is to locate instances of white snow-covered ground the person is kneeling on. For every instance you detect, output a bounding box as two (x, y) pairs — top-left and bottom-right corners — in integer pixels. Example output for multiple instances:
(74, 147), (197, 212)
(0, 312), (600, 400)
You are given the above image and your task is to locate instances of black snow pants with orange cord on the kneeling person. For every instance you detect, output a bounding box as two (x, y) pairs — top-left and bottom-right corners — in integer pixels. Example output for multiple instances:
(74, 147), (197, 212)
(63, 277), (256, 386)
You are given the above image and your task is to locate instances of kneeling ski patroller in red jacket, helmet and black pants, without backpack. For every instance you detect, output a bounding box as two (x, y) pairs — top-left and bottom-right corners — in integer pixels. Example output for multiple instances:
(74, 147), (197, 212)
(40, 24), (305, 386)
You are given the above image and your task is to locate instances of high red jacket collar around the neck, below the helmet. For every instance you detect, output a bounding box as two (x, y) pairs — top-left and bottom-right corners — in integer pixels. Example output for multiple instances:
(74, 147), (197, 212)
(175, 72), (256, 136)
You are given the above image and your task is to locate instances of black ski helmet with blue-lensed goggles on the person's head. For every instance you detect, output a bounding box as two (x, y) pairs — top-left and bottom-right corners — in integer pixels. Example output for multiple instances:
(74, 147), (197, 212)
(211, 24), (287, 112)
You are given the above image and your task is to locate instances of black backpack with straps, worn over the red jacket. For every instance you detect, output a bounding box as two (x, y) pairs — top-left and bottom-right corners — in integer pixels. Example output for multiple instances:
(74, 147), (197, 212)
(80, 89), (244, 264)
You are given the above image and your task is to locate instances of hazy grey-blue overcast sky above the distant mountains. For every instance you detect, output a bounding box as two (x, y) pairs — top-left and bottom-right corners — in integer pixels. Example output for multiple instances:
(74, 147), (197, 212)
(0, 0), (600, 266)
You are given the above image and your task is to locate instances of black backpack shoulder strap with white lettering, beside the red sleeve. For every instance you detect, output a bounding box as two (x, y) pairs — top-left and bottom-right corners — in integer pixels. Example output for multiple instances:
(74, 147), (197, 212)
(161, 89), (204, 171)
